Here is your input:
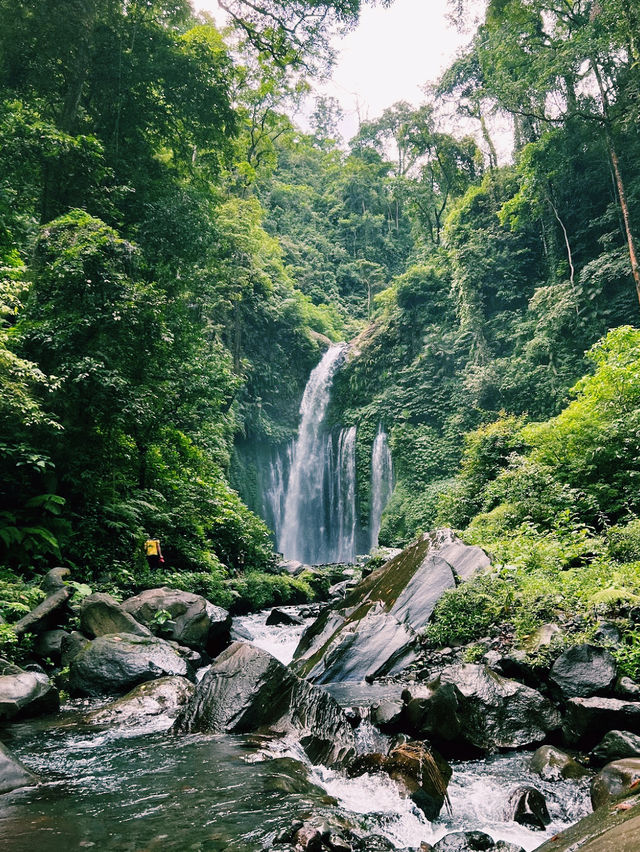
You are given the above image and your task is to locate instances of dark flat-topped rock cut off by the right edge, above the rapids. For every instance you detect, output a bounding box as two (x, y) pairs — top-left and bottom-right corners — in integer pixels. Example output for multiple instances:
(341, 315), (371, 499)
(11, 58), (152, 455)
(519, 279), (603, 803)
(562, 698), (640, 750)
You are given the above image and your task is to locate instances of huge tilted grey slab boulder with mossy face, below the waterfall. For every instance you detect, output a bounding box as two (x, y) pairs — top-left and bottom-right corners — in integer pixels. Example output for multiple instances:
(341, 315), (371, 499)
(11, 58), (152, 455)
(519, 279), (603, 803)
(292, 530), (489, 683)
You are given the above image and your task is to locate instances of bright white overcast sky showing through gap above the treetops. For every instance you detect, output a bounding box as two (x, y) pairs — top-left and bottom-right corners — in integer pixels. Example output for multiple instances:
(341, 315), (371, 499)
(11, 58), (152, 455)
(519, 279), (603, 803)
(193, 0), (476, 138)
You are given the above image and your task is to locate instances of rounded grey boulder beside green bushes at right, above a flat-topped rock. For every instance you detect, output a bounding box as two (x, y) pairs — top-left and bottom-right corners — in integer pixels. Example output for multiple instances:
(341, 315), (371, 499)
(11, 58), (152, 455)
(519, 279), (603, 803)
(550, 645), (616, 698)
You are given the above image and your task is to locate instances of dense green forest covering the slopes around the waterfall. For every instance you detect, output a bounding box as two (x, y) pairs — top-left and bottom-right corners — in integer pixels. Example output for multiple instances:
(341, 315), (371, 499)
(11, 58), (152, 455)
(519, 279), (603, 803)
(0, 0), (640, 664)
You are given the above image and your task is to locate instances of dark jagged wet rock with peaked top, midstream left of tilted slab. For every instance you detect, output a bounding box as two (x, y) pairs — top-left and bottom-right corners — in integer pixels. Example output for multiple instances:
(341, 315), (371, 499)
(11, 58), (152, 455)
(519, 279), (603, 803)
(174, 642), (355, 765)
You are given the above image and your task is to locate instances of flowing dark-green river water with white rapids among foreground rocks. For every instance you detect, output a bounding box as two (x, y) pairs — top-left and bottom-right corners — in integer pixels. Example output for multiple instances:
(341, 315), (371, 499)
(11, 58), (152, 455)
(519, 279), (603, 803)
(0, 613), (589, 852)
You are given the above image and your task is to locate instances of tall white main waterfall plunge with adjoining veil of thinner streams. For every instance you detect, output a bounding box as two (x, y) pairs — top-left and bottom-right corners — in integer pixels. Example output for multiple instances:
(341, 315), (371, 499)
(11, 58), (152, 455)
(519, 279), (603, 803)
(278, 343), (358, 565)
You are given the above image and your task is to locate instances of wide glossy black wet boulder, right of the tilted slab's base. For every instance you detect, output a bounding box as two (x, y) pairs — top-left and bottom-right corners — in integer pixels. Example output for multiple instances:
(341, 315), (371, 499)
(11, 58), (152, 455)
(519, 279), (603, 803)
(405, 663), (560, 751)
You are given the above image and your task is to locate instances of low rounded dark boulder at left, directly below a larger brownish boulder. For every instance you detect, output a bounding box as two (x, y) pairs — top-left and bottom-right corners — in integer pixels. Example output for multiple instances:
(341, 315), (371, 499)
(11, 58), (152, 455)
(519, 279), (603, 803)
(69, 633), (187, 696)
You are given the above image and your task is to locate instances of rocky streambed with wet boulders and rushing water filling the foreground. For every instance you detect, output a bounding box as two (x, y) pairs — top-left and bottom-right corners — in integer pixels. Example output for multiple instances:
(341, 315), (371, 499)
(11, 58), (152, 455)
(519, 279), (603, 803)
(0, 534), (640, 852)
